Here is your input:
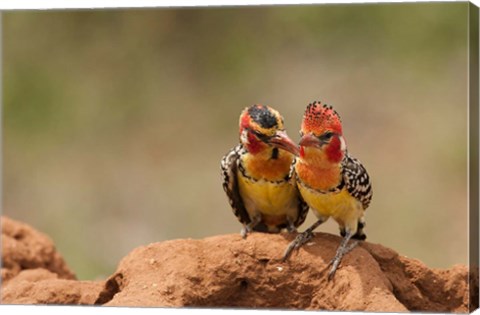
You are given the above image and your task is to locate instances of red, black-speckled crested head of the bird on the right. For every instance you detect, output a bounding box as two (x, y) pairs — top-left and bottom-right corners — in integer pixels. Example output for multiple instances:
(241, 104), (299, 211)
(299, 102), (346, 163)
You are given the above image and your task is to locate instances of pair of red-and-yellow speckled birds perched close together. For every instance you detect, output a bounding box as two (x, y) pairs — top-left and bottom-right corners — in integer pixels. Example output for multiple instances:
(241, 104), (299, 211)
(221, 102), (372, 279)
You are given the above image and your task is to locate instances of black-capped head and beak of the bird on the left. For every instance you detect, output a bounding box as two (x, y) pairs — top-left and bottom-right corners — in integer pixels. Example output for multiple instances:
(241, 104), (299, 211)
(240, 104), (298, 155)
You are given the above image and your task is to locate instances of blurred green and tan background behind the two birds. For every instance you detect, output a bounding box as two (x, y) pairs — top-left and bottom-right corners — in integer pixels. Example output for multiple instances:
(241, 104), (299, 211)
(3, 2), (468, 279)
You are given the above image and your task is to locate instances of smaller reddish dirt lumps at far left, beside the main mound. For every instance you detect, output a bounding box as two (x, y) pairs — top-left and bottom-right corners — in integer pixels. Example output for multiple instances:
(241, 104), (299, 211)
(0, 216), (103, 304)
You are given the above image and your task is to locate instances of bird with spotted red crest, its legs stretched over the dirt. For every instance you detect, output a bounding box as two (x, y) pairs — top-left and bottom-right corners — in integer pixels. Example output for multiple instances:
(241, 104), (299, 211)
(282, 101), (373, 280)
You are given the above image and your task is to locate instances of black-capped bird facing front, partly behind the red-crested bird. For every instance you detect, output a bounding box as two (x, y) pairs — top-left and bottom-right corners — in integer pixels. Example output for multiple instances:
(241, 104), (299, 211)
(221, 104), (308, 238)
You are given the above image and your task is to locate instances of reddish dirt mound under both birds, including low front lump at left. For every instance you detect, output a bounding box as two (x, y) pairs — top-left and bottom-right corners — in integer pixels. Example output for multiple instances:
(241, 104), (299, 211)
(2, 216), (478, 312)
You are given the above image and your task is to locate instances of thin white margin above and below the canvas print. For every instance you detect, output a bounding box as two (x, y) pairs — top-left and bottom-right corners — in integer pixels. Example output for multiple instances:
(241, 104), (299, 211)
(0, 0), (480, 315)
